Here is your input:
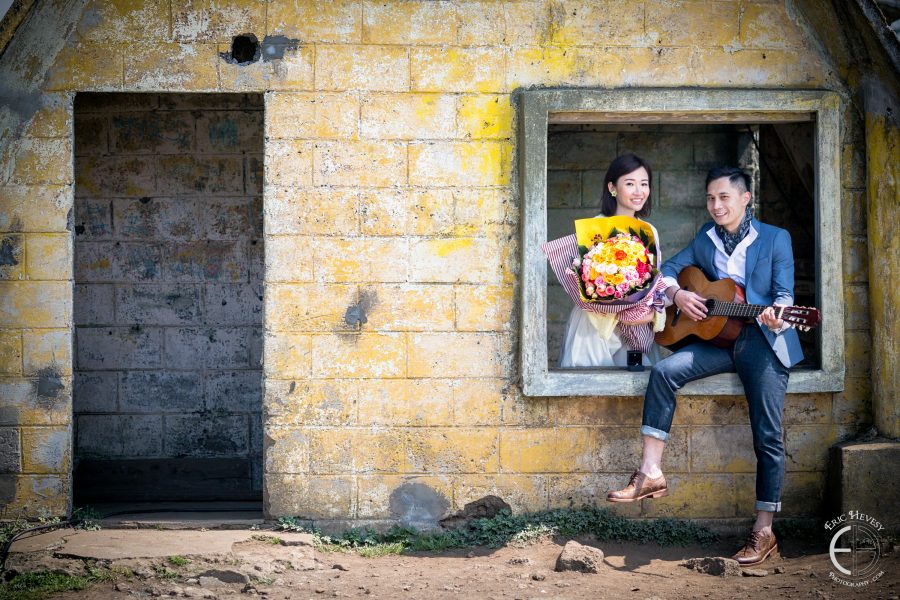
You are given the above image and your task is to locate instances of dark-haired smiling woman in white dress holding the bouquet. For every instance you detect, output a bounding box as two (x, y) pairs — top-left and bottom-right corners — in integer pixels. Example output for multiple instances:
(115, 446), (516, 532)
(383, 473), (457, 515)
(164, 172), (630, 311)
(559, 154), (662, 367)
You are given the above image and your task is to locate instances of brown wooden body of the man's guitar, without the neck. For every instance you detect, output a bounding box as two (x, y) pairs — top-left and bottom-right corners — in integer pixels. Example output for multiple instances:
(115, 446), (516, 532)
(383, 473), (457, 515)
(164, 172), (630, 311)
(656, 267), (746, 350)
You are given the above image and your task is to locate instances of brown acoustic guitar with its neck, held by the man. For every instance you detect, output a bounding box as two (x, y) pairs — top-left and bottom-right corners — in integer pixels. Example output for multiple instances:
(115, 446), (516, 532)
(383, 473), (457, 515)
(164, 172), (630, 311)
(656, 267), (821, 349)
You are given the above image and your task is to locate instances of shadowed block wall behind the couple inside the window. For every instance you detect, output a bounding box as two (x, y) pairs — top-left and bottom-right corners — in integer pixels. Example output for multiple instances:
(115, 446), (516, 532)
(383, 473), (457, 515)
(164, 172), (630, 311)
(547, 125), (746, 368)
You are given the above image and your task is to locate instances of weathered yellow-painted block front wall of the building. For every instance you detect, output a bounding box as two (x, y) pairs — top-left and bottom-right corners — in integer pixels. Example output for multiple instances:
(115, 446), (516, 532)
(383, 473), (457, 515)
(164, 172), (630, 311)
(0, 0), (871, 523)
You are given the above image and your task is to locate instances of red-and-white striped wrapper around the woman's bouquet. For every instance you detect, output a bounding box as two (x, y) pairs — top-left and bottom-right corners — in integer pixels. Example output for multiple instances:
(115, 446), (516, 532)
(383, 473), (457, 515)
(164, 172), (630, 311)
(541, 235), (666, 353)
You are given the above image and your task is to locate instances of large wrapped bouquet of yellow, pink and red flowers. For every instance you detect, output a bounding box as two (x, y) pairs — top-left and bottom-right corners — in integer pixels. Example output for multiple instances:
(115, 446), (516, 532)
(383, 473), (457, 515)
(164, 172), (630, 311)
(541, 217), (665, 352)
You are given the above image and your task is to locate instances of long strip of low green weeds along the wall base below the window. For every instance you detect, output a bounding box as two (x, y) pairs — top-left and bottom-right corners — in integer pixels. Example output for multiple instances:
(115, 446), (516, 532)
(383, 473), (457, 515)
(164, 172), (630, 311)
(278, 506), (716, 556)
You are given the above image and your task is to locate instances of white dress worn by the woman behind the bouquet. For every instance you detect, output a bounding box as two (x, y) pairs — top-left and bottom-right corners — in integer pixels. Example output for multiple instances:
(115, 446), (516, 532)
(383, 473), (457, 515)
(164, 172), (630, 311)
(559, 220), (662, 368)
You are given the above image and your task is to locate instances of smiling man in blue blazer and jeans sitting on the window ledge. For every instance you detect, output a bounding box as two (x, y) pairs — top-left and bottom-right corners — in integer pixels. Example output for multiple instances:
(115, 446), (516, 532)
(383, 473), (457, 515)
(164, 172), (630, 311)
(607, 167), (803, 566)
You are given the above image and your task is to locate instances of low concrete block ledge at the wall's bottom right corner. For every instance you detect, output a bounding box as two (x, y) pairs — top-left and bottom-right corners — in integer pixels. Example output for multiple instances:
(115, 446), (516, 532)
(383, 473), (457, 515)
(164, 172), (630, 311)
(827, 439), (900, 537)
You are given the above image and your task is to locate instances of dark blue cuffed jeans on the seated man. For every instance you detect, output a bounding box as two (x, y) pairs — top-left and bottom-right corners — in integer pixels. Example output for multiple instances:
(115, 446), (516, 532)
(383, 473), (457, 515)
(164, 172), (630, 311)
(641, 323), (789, 512)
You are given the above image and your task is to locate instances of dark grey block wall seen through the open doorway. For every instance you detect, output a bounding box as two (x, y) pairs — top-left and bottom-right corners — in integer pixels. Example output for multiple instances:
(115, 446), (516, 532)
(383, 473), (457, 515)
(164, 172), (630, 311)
(73, 94), (263, 496)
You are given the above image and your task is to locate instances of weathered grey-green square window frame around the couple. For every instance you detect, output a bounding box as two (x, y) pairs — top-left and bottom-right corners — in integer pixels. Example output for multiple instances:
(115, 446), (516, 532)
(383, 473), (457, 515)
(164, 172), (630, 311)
(518, 88), (845, 396)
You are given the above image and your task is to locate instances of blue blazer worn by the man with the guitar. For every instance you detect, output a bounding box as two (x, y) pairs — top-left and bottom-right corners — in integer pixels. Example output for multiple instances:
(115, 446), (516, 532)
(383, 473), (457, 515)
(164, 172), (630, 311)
(662, 219), (803, 367)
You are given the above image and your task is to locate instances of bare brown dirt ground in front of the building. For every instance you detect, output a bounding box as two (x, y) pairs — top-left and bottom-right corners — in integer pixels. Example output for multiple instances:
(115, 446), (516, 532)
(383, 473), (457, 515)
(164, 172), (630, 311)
(10, 538), (900, 600)
